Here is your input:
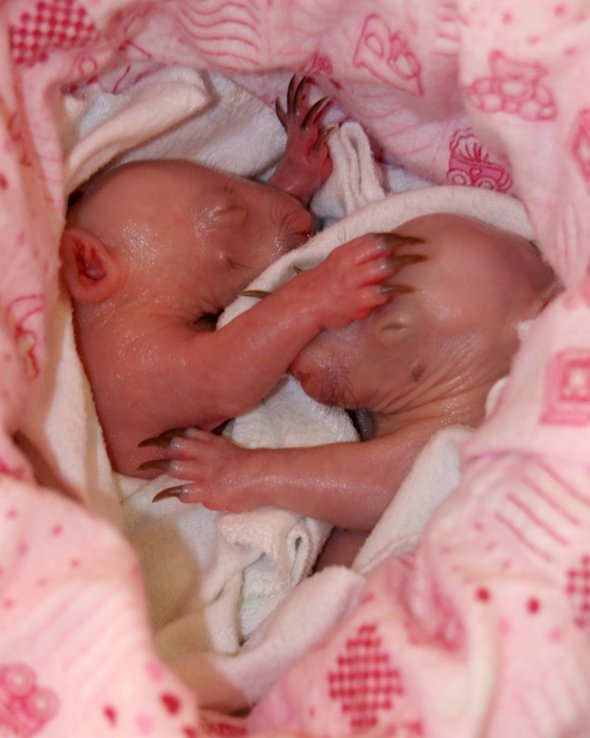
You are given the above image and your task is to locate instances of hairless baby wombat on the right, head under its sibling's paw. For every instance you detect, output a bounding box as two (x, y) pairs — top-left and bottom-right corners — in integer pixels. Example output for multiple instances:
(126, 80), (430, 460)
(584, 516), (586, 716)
(147, 214), (556, 564)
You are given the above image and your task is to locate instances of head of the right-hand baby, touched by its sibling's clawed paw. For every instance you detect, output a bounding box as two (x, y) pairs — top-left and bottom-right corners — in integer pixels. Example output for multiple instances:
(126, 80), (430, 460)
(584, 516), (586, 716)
(290, 214), (555, 410)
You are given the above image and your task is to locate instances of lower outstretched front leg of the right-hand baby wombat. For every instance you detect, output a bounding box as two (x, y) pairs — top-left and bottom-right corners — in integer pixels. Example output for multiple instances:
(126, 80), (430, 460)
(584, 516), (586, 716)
(141, 424), (432, 531)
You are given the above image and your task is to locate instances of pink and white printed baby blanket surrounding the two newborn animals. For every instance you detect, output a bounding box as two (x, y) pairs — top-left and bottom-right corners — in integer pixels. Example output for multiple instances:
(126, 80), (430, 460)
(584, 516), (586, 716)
(0, 0), (590, 738)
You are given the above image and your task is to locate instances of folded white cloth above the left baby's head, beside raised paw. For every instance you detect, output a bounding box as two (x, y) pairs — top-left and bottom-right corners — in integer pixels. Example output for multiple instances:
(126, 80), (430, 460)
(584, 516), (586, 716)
(63, 63), (292, 191)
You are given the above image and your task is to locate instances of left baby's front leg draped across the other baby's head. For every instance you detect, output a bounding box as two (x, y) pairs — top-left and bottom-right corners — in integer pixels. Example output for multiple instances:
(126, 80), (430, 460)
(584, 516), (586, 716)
(137, 233), (426, 466)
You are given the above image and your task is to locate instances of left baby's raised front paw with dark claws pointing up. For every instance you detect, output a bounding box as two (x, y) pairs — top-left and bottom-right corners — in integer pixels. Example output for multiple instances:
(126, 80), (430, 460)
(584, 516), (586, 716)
(268, 75), (333, 206)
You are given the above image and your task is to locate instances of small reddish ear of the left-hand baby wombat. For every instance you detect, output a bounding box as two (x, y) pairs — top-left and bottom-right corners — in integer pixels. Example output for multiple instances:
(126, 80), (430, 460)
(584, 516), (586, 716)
(60, 228), (121, 303)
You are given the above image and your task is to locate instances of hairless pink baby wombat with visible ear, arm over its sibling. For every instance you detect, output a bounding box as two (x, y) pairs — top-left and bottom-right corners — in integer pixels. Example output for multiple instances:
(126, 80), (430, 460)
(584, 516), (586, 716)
(61, 80), (420, 476)
